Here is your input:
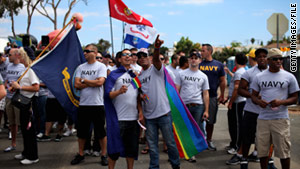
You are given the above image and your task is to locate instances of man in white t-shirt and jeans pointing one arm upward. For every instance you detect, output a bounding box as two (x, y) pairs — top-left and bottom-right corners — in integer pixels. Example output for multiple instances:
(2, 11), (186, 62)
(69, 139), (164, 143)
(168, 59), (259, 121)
(137, 35), (180, 169)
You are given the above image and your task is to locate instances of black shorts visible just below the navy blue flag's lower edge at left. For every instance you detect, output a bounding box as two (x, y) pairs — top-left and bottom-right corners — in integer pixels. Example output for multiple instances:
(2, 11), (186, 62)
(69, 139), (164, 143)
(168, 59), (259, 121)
(46, 98), (67, 125)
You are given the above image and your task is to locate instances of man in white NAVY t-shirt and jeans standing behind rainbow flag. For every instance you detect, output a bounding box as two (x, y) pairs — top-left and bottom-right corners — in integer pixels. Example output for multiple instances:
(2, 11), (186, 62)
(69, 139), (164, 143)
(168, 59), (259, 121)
(175, 53), (209, 162)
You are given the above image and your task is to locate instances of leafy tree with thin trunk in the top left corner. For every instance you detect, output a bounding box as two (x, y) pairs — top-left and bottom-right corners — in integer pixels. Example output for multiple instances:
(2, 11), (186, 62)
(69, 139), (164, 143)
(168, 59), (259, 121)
(0, 0), (23, 37)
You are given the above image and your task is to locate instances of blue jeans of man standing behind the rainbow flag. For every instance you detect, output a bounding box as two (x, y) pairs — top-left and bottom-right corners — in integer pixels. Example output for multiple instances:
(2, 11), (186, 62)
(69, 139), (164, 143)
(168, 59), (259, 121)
(188, 104), (206, 138)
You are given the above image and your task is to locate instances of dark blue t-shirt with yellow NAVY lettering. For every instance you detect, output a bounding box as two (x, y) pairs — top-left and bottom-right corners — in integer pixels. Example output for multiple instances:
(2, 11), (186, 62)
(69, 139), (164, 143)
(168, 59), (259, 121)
(199, 60), (225, 97)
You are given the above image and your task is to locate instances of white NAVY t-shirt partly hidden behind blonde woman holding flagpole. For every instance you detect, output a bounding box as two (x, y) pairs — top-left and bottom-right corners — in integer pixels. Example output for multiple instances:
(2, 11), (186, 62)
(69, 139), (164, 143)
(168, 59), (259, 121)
(5, 63), (25, 99)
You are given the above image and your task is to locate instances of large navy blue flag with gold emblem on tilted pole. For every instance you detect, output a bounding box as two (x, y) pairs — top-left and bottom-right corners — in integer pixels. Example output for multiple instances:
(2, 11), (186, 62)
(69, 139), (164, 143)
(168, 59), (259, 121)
(31, 26), (86, 117)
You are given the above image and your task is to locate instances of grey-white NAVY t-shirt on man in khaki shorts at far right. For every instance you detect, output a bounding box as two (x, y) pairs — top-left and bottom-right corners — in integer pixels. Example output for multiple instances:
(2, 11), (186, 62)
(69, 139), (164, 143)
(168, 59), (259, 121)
(251, 69), (299, 120)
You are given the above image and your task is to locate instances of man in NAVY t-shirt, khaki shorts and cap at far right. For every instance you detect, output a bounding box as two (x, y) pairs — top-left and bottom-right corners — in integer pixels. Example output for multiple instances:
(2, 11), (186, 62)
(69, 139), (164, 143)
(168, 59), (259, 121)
(250, 48), (300, 169)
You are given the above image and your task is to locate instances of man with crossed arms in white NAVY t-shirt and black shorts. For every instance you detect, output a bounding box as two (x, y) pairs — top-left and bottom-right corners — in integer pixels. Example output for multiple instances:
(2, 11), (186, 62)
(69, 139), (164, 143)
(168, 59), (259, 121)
(71, 44), (108, 166)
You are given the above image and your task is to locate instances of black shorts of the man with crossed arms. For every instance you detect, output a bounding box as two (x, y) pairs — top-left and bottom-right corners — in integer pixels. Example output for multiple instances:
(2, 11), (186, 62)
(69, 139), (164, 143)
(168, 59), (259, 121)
(77, 106), (106, 139)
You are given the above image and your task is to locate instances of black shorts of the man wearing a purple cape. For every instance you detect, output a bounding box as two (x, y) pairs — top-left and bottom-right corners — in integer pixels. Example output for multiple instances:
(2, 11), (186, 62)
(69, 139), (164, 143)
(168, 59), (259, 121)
(108, 120), (140, 161)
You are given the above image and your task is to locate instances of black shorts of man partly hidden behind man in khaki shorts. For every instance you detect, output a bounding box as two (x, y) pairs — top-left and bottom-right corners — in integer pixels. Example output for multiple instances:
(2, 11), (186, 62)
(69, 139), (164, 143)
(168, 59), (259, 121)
(242, 111), (258, 145)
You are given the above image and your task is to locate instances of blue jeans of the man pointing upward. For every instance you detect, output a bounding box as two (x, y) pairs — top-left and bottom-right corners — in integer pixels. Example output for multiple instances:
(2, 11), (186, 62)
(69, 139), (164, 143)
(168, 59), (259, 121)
(146, 113), (180, 169)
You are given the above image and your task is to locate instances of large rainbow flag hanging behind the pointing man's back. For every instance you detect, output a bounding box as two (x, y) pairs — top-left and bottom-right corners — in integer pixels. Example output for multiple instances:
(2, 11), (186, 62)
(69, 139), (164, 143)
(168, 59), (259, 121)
(164, 68), (207, 159)
